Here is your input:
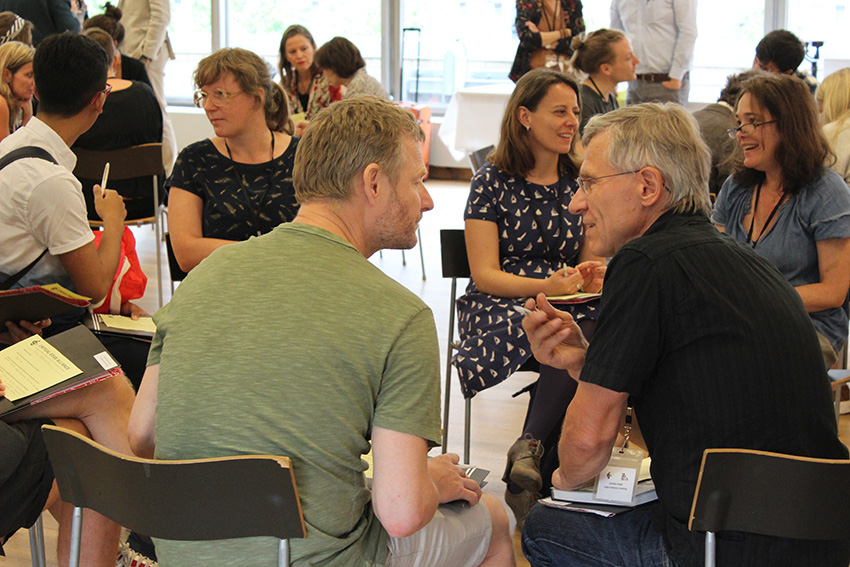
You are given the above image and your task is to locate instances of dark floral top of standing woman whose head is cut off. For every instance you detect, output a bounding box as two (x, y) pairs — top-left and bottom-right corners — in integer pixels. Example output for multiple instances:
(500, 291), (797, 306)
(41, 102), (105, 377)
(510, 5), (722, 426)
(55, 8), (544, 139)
(508, 0), (584, 82)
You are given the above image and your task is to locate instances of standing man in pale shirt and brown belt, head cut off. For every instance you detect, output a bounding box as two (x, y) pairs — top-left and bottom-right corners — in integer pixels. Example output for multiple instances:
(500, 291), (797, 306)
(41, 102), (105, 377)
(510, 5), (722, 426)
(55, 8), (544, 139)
(611, 0), (697, 106)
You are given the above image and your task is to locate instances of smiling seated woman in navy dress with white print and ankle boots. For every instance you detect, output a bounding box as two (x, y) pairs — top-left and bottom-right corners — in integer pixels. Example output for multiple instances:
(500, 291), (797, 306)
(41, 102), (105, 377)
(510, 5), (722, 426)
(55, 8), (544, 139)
(453, 69), (605, 523)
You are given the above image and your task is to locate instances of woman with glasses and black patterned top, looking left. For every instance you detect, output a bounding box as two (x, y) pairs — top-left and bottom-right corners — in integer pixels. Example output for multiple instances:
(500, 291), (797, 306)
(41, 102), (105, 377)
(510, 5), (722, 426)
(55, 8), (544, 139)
(167, 48), (298, 272)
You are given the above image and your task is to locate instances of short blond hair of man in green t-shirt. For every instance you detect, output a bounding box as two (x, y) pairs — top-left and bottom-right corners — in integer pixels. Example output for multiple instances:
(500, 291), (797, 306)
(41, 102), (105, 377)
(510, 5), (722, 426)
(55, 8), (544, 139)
(292, 96), (425, 204)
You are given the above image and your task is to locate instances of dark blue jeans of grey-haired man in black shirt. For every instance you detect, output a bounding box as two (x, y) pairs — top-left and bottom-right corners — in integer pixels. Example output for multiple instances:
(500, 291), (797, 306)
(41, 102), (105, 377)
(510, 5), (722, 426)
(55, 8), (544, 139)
(522, 504), (675, 567)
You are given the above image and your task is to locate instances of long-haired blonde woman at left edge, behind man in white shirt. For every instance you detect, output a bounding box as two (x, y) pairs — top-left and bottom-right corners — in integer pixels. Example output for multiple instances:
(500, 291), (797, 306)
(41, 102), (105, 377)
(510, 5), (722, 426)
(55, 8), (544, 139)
(0, 41), (35, 140)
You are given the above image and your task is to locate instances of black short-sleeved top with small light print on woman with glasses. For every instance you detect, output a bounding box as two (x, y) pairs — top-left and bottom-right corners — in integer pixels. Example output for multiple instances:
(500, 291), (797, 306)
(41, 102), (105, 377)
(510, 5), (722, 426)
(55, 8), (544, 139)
(166, 138), (298, 241)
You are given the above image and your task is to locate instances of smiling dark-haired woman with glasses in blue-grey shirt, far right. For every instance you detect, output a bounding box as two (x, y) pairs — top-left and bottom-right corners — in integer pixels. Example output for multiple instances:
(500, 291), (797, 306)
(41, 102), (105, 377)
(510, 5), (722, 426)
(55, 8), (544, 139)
(712, 74), (850, 368)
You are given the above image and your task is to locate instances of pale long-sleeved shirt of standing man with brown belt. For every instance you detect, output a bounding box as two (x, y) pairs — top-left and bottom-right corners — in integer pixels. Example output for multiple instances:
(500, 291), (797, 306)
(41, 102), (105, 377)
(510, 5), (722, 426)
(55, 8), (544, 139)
(611, 0), (697, 81)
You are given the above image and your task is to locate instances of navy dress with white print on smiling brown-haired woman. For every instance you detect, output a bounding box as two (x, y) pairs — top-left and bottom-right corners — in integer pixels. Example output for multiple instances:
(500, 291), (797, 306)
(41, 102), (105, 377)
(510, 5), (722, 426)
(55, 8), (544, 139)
(452, 162), (598, 398)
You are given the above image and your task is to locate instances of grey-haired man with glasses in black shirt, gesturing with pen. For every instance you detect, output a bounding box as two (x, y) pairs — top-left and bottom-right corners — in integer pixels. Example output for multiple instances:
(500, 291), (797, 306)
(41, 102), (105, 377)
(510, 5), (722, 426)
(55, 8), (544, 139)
(523, 104), (850, 567)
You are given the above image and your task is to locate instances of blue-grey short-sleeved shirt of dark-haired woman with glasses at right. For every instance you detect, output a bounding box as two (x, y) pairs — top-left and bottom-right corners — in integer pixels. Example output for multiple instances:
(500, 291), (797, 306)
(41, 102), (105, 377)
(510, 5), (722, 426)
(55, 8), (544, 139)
(711, 169), (850, 352)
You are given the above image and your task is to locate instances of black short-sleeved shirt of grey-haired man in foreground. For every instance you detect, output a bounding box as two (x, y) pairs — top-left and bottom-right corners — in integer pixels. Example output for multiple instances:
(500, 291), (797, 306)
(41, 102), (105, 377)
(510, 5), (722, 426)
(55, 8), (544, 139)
(581, 212), (850, 567)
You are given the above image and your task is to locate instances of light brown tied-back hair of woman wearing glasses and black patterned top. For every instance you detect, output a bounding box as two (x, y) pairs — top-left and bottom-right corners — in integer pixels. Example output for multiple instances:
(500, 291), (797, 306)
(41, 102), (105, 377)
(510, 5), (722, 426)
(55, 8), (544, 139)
(194, 47), (293, 134)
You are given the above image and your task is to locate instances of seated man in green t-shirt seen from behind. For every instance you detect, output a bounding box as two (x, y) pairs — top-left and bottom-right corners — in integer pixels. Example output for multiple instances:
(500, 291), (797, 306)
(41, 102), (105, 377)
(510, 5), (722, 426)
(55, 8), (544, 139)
(130, 96), (514, 567)
